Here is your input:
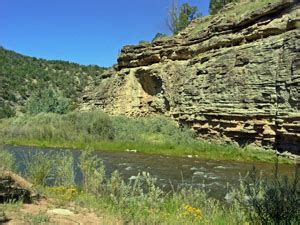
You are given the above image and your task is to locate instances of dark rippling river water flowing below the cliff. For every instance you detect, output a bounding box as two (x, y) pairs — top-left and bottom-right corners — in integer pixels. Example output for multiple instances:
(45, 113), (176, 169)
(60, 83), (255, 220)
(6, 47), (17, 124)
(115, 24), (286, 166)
(5, 146), (294, 199)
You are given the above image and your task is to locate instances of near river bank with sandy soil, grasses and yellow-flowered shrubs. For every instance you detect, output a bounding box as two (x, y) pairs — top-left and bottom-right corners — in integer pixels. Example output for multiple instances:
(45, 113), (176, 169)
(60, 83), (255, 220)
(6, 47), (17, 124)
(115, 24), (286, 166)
(0, 150), (300, 224)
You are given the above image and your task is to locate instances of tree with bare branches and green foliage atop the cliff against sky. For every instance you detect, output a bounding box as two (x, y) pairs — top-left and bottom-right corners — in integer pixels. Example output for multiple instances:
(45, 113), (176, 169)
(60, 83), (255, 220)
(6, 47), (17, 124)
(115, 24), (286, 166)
(167, 0), (201, 34)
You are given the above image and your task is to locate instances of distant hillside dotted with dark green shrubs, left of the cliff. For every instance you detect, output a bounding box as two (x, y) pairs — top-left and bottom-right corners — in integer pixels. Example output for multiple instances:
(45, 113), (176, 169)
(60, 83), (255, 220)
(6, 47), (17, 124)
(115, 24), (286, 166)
(0, 48), (105, 118)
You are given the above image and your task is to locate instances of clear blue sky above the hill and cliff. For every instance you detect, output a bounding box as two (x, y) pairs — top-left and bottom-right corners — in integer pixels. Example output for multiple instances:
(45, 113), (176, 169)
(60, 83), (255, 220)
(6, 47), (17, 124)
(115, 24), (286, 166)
(0, 0), (209, 66)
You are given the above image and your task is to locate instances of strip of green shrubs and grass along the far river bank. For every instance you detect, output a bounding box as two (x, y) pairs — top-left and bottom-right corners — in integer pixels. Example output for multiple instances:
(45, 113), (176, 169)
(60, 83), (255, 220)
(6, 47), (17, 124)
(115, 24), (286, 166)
(0, 111), (289, 162)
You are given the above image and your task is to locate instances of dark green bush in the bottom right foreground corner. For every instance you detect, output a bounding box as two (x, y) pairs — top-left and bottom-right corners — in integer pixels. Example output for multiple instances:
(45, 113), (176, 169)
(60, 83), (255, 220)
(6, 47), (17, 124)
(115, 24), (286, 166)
(238, 160), (300, 224)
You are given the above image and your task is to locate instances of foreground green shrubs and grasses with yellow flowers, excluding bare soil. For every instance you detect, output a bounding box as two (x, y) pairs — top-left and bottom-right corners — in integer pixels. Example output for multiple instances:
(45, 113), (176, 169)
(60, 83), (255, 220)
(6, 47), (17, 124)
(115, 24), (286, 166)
(0, 152), (300, 225)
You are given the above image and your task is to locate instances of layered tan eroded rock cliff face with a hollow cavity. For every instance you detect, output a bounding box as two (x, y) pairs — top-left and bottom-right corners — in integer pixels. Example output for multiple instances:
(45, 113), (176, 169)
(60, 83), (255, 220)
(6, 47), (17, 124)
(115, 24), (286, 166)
(83, 0), (300, 154)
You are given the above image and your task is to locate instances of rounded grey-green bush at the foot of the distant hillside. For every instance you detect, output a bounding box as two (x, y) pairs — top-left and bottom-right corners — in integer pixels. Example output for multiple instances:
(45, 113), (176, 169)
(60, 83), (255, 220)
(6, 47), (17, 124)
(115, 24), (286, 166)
(25, 88), (71, 115)
